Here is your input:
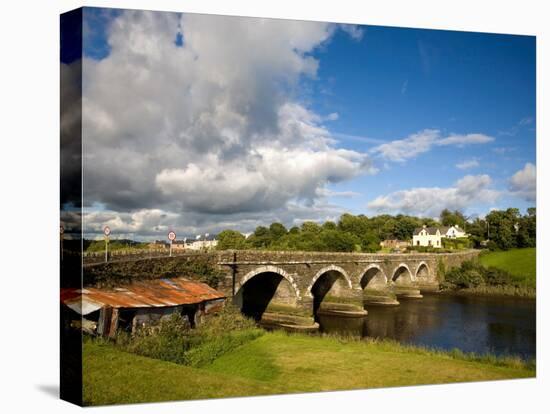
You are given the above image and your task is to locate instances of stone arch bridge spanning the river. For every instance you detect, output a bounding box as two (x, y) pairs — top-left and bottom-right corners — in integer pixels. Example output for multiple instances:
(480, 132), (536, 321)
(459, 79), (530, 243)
(215, 250), (479, 329)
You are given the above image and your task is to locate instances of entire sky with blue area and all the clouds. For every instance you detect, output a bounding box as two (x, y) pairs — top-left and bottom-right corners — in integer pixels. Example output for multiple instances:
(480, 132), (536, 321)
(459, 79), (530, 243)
(75, 8), (536, 237)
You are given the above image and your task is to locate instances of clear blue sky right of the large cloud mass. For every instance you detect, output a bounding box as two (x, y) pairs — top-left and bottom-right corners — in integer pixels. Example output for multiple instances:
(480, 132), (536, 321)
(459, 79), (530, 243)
(309, 26), (536, 217)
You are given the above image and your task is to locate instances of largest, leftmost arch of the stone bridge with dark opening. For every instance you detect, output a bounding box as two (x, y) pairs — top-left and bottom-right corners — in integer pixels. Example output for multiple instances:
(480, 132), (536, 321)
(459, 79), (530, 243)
(233, 266), (301, 321)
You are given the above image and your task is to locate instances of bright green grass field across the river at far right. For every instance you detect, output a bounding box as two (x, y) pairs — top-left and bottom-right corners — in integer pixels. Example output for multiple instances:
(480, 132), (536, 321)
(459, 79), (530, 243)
(480, 248), (537, 287)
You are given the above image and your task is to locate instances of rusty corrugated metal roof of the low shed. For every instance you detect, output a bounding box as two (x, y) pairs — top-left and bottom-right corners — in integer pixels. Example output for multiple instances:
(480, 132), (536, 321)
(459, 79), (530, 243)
(61, 278), (225, 315)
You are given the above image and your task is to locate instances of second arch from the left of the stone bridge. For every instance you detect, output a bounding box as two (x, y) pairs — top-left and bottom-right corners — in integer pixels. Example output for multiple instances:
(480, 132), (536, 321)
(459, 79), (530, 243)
(306, 265), (366, 319)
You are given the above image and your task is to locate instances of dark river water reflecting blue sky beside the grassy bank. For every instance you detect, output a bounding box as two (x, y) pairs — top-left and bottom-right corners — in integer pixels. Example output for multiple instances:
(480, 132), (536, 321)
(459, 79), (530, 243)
(319, 294), (536, 359)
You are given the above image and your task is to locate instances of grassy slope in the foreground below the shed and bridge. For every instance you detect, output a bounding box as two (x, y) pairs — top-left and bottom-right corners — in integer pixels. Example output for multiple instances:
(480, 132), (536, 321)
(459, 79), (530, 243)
(84, 332), (535, 405)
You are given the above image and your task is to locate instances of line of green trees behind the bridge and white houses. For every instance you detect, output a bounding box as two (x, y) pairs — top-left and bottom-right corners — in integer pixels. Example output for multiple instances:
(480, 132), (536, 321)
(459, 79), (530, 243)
(217, 208), (536, 252)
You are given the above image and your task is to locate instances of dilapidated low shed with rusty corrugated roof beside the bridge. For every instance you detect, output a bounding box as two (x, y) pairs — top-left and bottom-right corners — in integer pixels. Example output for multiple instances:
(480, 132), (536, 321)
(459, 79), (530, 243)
(61, 278), (226, 337)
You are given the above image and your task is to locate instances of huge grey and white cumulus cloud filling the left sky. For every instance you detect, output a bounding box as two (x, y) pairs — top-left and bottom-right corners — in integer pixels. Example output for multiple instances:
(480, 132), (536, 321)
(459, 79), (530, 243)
(83, 11), (376, 236)
